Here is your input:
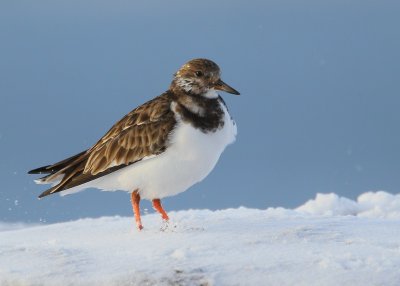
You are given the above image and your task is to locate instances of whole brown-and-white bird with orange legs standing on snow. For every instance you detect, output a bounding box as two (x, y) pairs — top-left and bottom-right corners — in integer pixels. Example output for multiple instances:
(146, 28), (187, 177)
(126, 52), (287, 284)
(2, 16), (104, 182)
(28, 58), (240, 230)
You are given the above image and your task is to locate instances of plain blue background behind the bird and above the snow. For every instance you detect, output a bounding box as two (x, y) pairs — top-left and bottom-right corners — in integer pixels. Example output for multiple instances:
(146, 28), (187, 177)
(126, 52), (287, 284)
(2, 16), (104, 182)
(0, 0), (400, 222)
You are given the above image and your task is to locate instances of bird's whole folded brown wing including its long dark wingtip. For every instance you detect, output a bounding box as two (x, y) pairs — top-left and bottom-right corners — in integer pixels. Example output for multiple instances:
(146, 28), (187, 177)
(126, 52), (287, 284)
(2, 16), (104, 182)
(39, 93), (176, 197)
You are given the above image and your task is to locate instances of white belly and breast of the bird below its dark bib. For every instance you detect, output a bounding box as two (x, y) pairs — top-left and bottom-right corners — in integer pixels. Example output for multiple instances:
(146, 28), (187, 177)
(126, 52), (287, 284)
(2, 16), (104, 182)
(61, 104), (236, 199)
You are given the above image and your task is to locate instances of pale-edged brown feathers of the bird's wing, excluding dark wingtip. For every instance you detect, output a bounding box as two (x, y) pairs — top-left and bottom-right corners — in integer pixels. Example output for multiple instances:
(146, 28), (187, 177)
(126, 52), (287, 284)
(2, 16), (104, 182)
(83, 94), (176, 175)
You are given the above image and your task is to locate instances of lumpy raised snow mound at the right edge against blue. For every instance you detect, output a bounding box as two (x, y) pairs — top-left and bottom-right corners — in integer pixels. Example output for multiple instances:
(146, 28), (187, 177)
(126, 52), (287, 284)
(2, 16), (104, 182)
(296, 191), (400, 219)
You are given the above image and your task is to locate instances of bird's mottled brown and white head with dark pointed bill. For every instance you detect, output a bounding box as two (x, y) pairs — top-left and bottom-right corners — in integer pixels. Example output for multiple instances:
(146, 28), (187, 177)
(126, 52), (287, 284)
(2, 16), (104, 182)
(170, 59), (240, 98)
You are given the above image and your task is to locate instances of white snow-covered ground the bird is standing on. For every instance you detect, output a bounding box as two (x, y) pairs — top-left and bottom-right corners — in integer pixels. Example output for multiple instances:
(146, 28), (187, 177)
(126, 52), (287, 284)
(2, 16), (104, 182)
(0, 192), (400, 286)
